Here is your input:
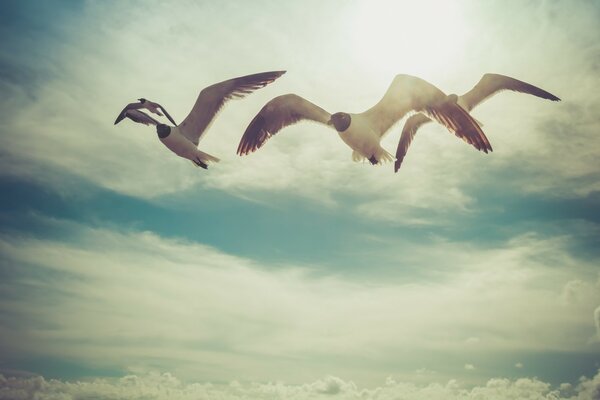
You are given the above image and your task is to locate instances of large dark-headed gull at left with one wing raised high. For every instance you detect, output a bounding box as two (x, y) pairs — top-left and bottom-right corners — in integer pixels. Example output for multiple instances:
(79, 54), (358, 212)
(115, 71), (285, 169)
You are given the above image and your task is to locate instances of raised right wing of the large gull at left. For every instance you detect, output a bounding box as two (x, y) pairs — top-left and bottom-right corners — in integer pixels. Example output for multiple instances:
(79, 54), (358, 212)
(179, 71), (285, 145)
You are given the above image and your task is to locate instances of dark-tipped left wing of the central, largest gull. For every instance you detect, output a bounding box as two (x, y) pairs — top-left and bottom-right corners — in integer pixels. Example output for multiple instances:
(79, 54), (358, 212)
(237, 94), (331, 156)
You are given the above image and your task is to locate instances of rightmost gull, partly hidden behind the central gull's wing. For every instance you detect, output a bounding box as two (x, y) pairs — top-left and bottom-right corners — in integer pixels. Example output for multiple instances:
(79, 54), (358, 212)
(394, 74), (560, 172)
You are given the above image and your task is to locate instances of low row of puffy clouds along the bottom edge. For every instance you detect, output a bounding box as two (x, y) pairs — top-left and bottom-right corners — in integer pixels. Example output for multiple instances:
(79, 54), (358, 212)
(0, 373), (600, 400)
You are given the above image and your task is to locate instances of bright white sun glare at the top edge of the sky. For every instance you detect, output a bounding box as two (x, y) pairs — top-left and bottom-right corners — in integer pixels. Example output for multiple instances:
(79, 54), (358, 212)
(351, 0), (467, 77)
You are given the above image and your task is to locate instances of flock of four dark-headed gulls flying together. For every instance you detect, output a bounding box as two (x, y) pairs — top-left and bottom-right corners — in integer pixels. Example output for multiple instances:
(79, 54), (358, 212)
(115, 71), (560, 172)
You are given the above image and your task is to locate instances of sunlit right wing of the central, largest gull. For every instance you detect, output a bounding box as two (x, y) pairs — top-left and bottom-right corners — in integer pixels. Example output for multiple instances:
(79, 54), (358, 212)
(363, 75), (492, 153)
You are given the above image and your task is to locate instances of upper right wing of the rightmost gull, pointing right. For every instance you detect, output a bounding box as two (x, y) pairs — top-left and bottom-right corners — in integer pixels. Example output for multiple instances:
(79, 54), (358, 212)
(460, 74), (560, 111)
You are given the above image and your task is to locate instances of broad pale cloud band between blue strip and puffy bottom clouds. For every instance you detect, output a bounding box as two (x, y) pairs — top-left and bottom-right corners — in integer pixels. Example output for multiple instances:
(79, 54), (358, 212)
(0, 222), (600, 382)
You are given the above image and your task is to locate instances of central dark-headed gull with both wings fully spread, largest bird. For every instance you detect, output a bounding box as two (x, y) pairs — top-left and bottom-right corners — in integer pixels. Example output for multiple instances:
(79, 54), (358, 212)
(237, 75), (492, 165)
